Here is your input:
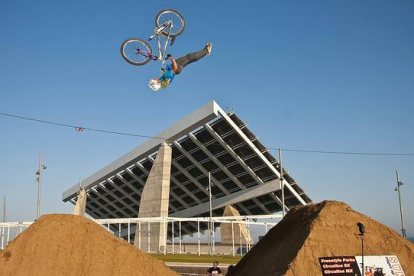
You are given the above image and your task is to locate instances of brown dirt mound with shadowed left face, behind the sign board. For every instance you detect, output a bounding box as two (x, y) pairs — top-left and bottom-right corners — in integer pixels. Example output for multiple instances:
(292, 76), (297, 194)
(228, 201), (414, 276)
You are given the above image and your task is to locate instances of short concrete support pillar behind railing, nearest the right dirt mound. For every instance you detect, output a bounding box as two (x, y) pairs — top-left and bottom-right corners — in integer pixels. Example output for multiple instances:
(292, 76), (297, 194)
(220, 205), (253, 244)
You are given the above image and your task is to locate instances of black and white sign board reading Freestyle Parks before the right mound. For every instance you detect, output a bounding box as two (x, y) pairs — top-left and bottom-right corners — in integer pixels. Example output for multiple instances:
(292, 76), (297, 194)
(319, 256), (405, 276)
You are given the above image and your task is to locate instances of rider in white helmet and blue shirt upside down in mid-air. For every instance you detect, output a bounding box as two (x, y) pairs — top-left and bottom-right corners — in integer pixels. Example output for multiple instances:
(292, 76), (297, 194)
(148, 43), (213, 91)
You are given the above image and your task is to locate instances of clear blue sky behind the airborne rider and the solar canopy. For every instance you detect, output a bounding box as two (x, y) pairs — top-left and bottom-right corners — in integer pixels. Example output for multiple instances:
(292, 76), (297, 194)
(0, 0), (414, 236)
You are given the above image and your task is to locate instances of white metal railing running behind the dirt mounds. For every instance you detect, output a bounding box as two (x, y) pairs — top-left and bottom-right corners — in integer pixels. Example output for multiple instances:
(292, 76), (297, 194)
(0, 214), (282, 256)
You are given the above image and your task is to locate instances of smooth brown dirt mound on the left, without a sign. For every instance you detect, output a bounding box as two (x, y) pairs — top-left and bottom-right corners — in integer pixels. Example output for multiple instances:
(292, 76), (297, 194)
(0, 215), (178, 276)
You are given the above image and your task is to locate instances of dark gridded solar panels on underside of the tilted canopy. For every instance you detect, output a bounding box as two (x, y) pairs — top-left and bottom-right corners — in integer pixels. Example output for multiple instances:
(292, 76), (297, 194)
(64, 108), (312, 239)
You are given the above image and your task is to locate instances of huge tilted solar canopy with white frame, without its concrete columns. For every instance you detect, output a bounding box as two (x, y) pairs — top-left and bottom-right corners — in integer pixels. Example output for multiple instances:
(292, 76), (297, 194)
(63, 101), (312, 237)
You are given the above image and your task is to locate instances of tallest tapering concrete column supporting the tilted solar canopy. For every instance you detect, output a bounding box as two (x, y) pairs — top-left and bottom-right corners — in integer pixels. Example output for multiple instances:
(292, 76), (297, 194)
(134, 143), (172, 252)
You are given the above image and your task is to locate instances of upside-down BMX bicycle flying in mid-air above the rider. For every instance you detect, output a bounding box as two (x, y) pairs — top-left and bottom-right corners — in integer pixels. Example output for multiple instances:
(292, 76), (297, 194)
(121, 9), (185, 67)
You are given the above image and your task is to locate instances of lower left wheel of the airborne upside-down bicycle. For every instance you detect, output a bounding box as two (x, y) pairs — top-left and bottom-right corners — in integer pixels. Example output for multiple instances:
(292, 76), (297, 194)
(121, 38), (152, 66)
